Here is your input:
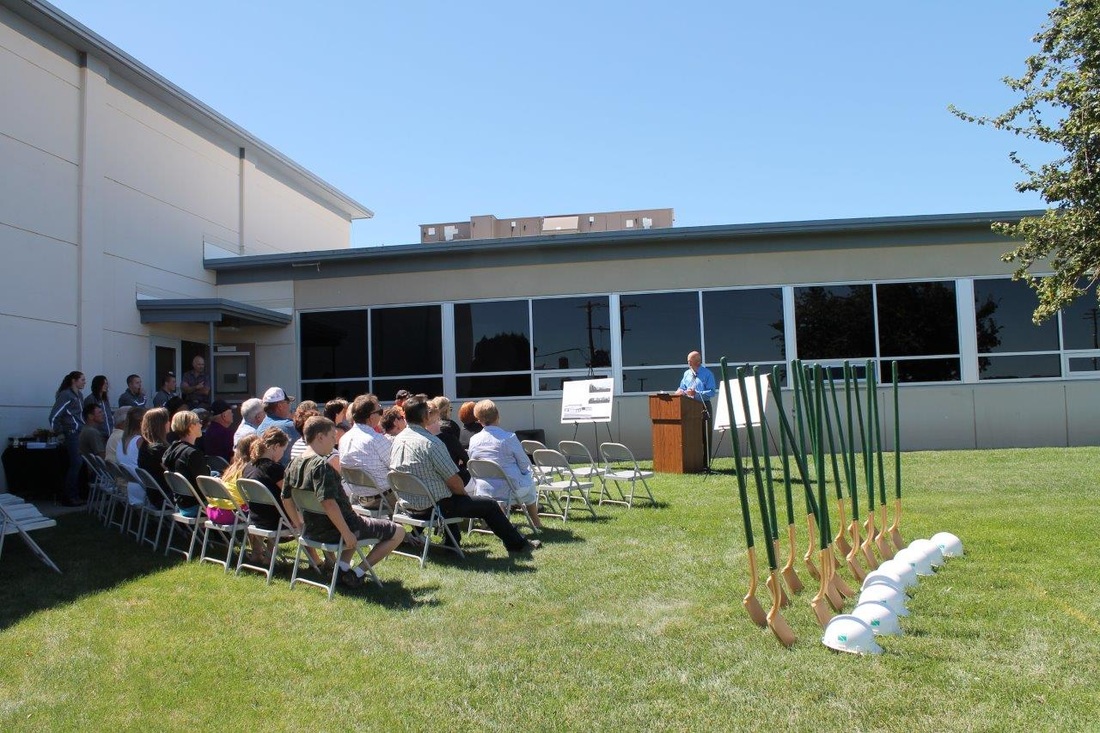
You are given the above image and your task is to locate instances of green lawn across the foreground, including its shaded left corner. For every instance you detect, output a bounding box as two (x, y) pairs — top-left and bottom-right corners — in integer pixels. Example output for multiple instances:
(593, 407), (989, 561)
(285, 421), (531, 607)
(0, 448), (1100, 731)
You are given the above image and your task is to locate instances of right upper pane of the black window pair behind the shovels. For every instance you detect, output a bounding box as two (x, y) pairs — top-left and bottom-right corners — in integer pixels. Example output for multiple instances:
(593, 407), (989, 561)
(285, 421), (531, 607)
(877, 283), (959, 354)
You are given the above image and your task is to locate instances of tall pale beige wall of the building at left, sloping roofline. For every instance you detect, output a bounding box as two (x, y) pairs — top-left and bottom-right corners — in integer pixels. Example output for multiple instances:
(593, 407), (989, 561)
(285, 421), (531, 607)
(0, 7), (352, 488)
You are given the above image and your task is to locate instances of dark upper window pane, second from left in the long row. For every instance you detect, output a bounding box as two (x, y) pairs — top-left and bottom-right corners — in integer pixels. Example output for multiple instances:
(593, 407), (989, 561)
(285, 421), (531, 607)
(371, 306), (443, 374)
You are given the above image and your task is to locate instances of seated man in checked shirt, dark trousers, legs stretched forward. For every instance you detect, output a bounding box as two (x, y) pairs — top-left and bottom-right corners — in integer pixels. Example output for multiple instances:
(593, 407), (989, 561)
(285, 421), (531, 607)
(389, 394), (542, 553)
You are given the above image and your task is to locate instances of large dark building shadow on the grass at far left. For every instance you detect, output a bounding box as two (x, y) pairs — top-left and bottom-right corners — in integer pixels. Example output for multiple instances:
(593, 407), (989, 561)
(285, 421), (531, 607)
(0, 514), (179, 630)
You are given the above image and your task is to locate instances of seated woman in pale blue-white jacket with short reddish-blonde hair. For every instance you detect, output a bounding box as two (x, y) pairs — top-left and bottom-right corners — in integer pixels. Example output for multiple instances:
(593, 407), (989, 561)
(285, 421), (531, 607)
(470, 400), (542, 528)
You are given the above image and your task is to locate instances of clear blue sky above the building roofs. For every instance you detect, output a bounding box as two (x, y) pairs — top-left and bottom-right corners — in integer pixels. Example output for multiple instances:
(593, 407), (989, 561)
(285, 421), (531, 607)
(53, 0), (1054, 245)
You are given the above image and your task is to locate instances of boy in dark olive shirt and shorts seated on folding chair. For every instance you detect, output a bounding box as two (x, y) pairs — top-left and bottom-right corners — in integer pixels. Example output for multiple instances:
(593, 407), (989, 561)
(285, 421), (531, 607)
(283, 415), (405, 588)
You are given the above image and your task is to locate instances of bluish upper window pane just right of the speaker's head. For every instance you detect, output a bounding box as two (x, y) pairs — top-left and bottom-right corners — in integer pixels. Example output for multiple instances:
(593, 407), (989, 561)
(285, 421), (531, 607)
(703, 287), (787, 364)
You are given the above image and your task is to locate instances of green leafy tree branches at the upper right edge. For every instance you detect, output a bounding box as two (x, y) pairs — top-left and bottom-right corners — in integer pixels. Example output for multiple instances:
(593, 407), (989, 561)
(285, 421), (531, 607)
(949, 0), (1100, 324)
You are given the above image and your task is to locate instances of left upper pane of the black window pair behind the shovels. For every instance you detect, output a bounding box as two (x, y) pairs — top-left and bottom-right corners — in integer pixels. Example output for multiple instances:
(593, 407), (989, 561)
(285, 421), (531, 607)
(794, 285), (875, 361)
